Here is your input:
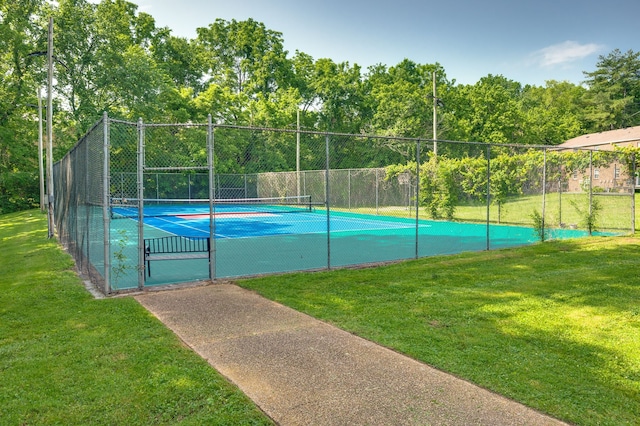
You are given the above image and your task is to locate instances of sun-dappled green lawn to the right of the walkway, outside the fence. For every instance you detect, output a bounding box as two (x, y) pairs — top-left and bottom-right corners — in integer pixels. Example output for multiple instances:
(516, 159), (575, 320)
(239, 237), (640, 425)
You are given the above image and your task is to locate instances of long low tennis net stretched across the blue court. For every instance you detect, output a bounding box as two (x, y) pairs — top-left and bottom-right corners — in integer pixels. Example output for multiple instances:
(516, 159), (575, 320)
(110, 195), (314, 219)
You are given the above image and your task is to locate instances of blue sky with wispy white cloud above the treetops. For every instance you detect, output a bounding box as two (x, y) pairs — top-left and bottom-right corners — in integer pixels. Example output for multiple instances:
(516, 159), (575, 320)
(132, 0), (640, 86)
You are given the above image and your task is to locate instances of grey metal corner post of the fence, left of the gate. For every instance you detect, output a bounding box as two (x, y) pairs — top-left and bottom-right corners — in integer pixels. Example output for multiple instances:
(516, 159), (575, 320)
(102, 111), (111, 294)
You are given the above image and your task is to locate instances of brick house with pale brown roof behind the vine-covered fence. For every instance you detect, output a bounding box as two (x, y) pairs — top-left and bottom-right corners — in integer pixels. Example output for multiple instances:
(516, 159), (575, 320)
(558, 126), (640, 192)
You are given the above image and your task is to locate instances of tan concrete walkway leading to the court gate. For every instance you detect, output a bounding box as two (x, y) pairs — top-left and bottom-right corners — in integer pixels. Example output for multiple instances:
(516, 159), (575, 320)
(136, 284), (563, 426)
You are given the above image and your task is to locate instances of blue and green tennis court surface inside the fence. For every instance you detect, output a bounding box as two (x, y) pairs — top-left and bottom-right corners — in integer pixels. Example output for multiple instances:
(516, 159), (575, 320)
(106, 200), (586, 288)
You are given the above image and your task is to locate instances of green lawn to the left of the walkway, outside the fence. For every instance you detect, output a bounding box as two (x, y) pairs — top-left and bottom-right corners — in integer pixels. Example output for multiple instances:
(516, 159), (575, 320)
(0, 211), (271, 425)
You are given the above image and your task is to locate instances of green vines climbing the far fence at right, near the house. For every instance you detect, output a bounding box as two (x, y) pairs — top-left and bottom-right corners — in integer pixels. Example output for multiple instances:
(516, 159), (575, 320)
(398, 148), (636, 226)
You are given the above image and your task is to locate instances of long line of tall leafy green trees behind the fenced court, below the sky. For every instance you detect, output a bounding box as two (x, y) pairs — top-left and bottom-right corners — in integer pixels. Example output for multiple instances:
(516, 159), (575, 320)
(0, 0), (640, 213)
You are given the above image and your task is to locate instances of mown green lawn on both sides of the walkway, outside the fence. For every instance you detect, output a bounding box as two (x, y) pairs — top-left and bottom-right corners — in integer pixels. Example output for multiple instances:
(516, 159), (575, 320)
(0, 208), (640, 425)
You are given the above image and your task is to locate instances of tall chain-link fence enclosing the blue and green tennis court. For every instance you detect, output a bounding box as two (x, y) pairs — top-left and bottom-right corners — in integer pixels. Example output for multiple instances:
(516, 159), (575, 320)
(54, 115), (635, 293)
